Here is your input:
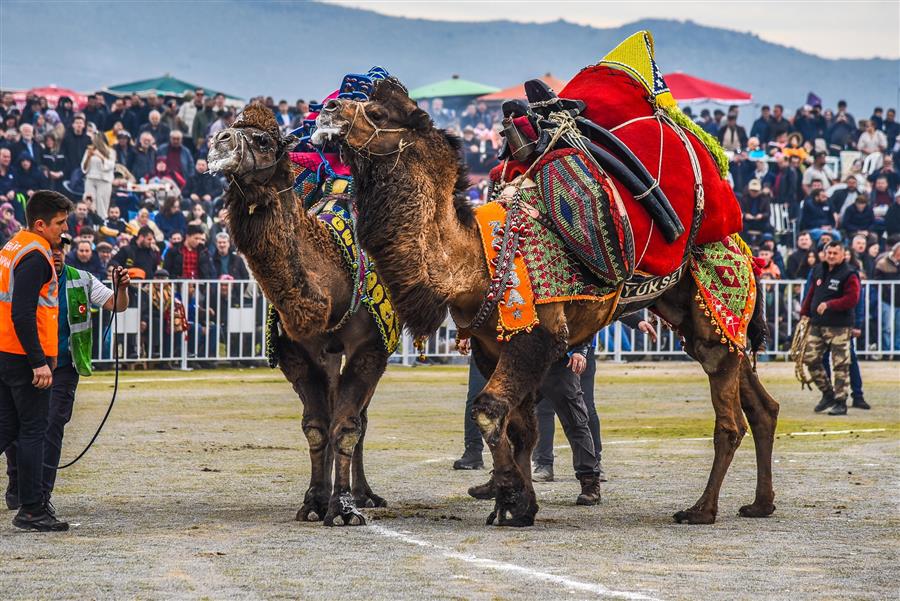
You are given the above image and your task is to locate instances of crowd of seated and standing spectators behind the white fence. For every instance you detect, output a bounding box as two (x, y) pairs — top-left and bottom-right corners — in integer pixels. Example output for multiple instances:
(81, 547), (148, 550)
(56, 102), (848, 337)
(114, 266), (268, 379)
(0, 88), (900, 358)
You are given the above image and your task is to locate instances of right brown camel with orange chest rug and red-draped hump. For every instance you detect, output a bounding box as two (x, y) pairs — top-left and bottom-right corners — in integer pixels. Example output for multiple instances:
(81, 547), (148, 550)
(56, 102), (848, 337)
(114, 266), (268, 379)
(318, 79), (778, 526)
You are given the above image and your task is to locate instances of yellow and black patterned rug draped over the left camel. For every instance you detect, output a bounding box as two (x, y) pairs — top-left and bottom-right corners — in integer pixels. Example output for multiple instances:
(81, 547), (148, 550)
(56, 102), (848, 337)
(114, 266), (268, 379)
(266, 195), (400, 367)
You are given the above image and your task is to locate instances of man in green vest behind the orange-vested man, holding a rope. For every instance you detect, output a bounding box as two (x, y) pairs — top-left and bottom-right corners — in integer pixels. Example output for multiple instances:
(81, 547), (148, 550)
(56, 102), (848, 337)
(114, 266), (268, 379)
(6, 223), (131, 528)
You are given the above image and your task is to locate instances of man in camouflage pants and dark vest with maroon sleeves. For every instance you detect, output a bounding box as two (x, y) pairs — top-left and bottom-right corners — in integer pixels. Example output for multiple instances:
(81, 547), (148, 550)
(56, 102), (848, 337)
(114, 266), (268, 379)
(800, 242), (861, 415)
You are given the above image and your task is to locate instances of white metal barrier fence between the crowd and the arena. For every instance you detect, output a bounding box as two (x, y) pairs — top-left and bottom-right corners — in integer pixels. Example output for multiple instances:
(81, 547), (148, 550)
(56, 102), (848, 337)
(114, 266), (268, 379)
(93, 280), (900, 368)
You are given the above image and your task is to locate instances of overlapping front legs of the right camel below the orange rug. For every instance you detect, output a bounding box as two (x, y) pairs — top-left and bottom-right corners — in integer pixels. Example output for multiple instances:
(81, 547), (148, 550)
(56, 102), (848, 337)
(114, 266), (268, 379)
(472, 327), (563, 526)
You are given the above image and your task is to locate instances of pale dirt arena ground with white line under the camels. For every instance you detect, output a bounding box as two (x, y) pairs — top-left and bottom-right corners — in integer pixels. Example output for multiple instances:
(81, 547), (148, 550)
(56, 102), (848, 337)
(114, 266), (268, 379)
(0, 362), (900, 601)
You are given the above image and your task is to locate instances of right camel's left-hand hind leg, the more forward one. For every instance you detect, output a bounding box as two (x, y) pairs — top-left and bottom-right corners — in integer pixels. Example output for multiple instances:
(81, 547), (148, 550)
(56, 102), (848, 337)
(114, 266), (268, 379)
(673, 338), (747, 524)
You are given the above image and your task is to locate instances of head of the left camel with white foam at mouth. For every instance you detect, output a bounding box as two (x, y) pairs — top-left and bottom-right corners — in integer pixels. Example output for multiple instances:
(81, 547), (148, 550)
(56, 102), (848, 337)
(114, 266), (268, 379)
(208, 104), (298, 184)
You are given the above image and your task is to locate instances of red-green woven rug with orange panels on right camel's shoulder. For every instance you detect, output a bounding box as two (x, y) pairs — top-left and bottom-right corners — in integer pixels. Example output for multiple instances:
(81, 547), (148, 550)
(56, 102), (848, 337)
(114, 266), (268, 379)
(475, 202), (617, 340)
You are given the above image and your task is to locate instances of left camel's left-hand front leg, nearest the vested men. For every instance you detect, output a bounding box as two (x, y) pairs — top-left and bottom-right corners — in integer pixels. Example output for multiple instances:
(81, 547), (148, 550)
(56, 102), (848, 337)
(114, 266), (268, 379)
(280, 342), (332, 522)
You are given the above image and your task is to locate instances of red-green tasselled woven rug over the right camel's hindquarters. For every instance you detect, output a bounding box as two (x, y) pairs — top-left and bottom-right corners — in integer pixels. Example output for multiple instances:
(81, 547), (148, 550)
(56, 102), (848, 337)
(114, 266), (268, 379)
(690, 234), (756, 351)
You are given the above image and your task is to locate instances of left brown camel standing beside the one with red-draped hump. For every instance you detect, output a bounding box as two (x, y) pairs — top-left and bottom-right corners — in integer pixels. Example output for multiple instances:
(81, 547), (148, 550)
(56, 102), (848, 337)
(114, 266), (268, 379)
(209, 105), (389, 526)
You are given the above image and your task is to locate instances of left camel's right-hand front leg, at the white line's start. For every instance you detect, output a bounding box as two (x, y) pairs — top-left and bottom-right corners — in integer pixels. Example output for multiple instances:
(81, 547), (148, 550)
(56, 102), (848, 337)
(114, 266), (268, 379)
(325, 340), (387, 526)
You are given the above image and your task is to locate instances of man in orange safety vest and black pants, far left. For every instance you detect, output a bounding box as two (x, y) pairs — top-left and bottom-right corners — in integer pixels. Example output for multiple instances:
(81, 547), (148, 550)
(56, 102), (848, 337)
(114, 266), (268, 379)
(0, 190), (71, 531)
